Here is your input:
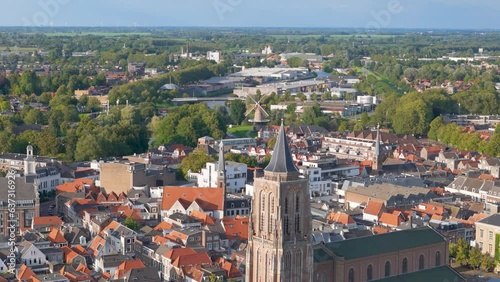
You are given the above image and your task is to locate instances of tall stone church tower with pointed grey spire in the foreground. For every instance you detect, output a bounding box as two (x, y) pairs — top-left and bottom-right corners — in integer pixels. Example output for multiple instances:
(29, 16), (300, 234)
(246, 121), (313, 282)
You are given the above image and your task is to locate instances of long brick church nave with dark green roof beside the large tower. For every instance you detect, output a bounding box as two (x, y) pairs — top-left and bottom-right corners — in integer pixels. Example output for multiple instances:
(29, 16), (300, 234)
(313, 227), (465, 282)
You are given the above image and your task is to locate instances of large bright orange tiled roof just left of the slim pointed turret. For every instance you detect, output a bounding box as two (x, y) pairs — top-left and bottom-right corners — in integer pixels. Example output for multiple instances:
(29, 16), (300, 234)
(162, 187), (224, 210)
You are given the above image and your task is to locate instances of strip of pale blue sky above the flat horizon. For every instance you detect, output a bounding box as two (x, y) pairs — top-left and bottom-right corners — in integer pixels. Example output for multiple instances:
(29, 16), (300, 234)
(0, 0), (500, 29)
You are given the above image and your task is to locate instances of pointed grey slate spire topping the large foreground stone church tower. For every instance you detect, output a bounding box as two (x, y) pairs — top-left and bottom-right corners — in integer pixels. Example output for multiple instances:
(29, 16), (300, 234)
(264, 122), (298, 173)
